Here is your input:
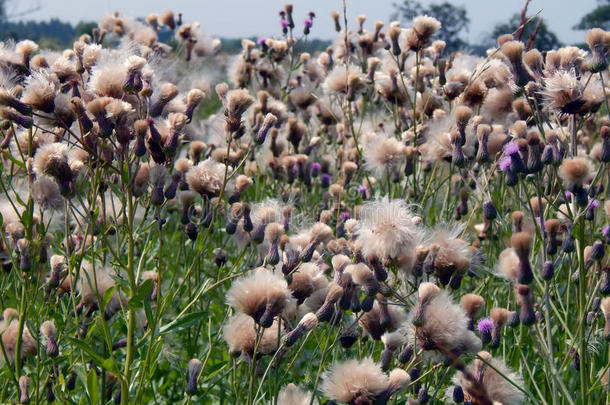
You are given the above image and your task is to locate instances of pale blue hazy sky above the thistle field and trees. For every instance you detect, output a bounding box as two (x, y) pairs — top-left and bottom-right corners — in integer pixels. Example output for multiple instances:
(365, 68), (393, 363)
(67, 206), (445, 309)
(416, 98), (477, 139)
(9, 0), (597, 43)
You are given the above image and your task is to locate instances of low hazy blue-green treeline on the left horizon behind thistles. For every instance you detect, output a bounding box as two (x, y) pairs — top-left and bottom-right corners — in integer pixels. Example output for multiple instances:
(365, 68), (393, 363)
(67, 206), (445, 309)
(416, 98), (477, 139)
(0, 18), (330, 54)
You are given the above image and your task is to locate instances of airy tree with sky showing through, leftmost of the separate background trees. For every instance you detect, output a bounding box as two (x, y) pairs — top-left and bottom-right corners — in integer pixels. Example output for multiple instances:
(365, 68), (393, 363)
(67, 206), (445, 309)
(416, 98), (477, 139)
(391, 0), (470, 52)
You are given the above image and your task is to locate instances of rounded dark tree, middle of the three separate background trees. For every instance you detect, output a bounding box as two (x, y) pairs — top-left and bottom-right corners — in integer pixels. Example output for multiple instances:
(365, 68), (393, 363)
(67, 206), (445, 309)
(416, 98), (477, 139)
(489, 13), (562, 50)
